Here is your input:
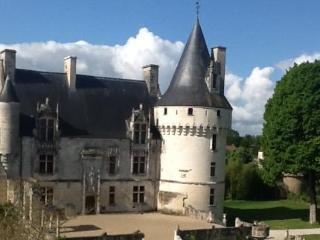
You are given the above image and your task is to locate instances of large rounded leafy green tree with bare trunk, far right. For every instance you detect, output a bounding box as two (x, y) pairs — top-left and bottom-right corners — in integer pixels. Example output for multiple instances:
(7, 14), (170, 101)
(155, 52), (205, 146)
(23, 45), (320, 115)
(262, 61), (320, 223)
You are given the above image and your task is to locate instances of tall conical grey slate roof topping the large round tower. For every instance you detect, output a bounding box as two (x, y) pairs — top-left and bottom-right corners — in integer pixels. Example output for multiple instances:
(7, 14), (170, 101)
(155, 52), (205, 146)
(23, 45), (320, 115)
(157, 18), (212, 106)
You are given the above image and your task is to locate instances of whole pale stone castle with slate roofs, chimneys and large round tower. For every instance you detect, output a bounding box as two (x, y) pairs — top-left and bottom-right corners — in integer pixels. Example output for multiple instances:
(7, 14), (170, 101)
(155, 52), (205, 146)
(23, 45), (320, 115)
(0, 19), (232, 219)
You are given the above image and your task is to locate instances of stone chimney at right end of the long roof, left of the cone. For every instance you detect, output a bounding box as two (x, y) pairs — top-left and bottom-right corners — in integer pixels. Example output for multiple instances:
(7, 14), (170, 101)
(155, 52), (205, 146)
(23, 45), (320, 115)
(142, 64), (160, 97)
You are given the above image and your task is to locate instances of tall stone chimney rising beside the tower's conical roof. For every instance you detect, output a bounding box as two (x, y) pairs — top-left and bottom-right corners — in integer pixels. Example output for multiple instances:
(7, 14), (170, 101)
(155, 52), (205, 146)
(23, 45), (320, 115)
(211, 47), (226, 95)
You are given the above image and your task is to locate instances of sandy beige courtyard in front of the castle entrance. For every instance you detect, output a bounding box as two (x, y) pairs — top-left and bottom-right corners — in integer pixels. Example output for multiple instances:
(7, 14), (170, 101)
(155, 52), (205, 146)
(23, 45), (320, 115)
(61, 213), (218, 240)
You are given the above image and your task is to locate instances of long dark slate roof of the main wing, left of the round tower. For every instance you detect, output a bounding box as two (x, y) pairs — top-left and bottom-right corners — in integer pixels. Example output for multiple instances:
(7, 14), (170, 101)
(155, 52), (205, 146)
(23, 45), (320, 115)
(15, 69), (155, 138)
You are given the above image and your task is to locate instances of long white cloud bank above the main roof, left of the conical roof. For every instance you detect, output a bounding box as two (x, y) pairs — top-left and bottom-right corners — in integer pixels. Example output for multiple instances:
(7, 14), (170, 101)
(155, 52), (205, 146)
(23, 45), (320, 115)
(0, 28), (184, 92)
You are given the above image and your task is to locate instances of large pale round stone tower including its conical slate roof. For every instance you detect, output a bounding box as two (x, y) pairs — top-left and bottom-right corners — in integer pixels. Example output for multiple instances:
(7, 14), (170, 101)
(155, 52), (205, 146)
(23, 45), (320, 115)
(154, 19), (232, 220)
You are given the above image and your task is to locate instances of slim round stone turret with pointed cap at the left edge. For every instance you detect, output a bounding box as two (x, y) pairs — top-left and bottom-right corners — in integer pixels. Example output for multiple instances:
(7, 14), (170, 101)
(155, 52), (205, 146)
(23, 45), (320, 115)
(0, 76), (20, 178)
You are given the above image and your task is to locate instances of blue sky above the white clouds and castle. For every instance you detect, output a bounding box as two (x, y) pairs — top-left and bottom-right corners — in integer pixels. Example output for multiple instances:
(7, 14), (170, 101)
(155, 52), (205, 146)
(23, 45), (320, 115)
(0, 0), (320, 134)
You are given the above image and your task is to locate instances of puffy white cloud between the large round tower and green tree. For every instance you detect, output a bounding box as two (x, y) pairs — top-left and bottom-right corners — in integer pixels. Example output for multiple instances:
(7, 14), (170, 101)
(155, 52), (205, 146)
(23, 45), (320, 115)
(226, 67), (274, 134)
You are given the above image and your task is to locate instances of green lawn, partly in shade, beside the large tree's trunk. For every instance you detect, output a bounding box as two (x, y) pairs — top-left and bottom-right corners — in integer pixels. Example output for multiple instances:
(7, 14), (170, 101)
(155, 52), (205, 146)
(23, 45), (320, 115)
(224, 200), (320, 229)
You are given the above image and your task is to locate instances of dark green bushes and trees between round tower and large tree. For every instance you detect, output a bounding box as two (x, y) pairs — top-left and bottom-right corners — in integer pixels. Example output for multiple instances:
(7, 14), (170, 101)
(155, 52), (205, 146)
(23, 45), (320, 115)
(226, 130), (279, 200)
